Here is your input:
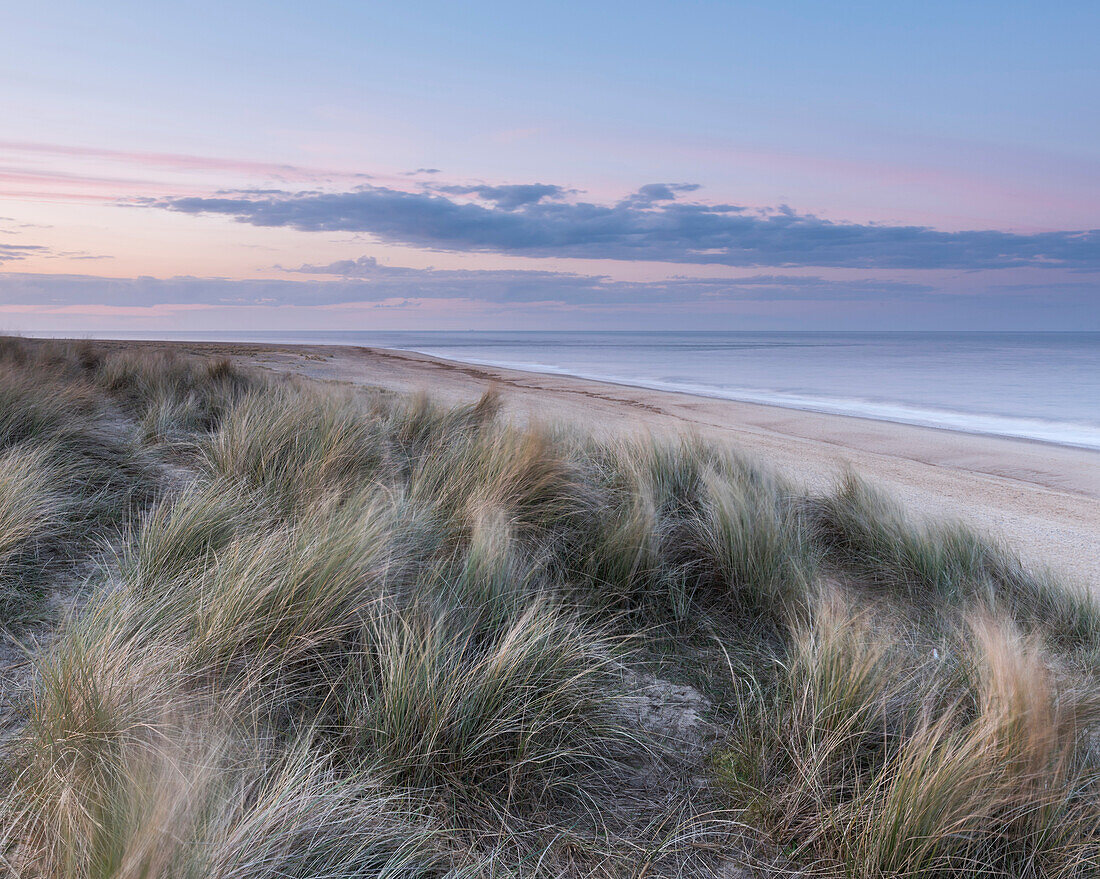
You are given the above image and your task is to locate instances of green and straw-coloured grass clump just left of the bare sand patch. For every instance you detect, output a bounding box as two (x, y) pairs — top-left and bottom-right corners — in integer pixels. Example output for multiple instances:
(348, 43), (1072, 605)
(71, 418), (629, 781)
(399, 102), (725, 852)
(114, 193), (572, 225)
(339, 600), (630, 801)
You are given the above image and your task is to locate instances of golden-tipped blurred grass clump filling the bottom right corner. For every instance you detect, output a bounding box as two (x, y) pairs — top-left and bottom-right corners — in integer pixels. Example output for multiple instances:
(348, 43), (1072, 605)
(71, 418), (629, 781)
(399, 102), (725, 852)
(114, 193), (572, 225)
(719, 598), (1100, 877)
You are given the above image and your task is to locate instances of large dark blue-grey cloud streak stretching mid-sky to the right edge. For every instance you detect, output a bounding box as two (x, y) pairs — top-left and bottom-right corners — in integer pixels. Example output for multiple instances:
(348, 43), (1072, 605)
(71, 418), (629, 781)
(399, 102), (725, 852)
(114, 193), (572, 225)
(150, 184), (1100, 270)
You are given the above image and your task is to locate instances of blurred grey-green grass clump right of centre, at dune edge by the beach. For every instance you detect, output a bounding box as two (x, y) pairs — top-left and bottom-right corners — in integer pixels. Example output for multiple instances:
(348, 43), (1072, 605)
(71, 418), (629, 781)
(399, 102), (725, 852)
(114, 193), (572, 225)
(578, 440), (814, 626)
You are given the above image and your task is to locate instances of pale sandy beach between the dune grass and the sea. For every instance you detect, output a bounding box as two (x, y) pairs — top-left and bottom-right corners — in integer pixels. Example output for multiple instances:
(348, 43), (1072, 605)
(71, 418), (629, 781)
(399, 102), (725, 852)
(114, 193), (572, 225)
(109, 343), (1100, 591)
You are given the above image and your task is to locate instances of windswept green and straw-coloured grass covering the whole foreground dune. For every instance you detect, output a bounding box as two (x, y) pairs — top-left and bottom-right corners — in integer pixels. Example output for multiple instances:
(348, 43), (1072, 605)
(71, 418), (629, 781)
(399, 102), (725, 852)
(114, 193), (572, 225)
(0, 340), (1100, 879)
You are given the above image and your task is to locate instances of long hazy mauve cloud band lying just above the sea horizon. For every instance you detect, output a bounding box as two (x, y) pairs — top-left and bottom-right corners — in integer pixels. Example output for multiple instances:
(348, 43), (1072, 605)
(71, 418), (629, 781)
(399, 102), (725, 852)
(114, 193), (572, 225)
(0, 256), (1100, 330)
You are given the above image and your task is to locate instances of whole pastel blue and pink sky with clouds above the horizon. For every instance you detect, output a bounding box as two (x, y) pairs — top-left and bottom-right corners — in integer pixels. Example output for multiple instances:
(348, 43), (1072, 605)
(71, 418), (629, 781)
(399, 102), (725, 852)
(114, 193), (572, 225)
(0, 0), (1100, 336)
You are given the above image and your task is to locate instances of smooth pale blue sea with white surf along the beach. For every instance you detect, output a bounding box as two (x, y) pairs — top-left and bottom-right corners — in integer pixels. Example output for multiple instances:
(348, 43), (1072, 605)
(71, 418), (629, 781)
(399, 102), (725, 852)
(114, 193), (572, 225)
(58, 331), (1100, 449)
